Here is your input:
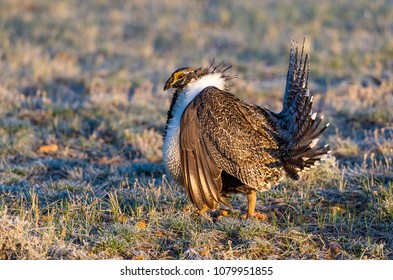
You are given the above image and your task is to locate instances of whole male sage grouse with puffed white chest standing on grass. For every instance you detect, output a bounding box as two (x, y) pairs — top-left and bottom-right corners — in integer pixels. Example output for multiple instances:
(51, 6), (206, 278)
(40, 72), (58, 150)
(163, 42), (329, 218)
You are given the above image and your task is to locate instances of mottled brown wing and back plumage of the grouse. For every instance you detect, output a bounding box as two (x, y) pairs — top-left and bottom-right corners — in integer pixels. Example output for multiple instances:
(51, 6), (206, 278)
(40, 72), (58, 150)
(180, 87), (281, 209)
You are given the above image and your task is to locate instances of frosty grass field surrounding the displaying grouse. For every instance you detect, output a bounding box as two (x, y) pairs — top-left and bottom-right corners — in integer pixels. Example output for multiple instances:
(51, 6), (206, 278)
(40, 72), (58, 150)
(0, 0), (393, 259)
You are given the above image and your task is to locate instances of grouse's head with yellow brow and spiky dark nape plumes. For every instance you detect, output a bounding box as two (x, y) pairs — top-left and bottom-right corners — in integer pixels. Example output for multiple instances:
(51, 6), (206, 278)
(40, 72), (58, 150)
(164, 60), (235, 91)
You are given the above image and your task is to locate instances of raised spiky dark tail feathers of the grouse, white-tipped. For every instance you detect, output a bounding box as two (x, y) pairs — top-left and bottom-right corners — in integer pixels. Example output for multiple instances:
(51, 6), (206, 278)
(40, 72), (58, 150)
(279, 38), (330, 180)
